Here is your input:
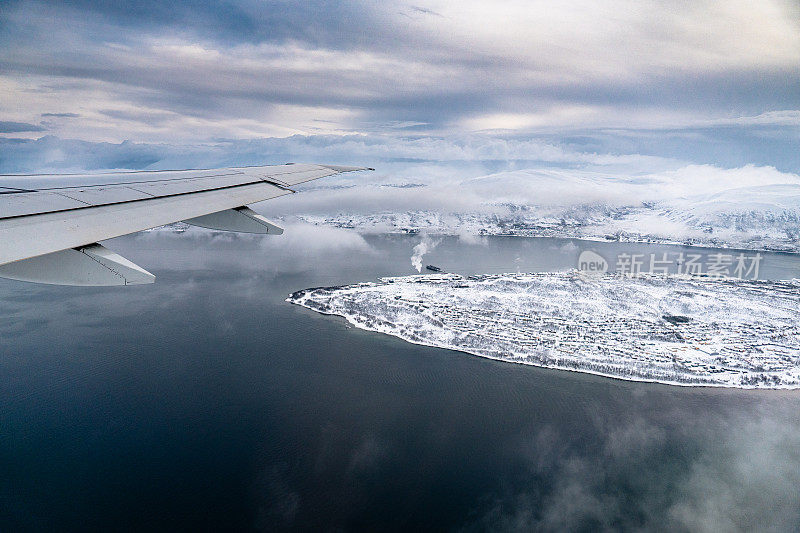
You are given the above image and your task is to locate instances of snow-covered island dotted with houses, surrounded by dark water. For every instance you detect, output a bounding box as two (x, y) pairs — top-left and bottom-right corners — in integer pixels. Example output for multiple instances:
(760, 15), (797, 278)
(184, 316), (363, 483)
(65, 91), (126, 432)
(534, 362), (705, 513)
(287, 271), (800, 389)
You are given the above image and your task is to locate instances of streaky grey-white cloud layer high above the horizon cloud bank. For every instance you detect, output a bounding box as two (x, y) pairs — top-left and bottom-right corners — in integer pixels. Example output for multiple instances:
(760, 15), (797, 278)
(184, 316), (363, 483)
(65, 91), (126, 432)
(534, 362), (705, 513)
(0, 0), (800, 143)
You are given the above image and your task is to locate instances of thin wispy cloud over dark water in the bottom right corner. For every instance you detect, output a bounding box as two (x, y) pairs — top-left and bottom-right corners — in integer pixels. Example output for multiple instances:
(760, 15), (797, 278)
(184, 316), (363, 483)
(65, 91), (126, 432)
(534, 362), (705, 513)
(463, 400), (800, 532)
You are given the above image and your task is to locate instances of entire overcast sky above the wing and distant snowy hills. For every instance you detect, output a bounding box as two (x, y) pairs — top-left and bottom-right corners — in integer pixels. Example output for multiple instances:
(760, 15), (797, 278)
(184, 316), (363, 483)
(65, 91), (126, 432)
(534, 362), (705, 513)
(0, 0), (800, 175)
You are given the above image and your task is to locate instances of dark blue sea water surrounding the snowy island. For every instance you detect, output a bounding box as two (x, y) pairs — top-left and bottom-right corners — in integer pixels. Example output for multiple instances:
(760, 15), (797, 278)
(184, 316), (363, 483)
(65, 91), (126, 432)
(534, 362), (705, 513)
(0, 233), (800, 531)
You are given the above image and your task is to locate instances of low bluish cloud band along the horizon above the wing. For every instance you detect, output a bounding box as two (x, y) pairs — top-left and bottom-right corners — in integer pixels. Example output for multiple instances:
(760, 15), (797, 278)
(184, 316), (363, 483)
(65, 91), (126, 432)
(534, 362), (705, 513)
(0, 132), (673, 174)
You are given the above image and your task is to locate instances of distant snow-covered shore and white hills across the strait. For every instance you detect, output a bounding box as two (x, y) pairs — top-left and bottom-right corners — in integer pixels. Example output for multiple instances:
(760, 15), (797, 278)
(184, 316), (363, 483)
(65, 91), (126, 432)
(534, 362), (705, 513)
(284, 165), (800, 252)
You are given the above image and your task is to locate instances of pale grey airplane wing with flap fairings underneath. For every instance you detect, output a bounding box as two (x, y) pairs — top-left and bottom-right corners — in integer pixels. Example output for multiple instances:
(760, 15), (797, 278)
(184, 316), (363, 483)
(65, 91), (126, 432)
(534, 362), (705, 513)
(0, 164), (372, 286)
